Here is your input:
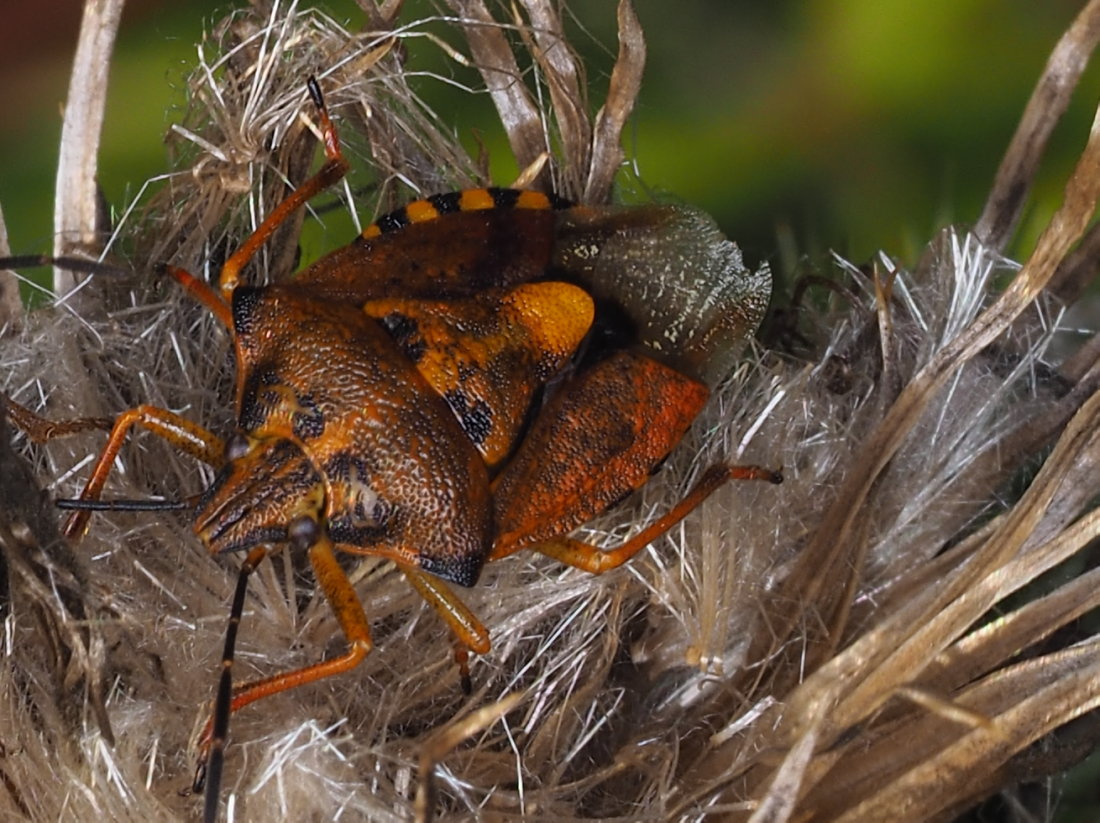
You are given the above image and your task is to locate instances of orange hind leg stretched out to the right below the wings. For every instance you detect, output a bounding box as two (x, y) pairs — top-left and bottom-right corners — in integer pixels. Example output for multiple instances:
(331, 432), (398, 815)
(523, 465), (783, 574)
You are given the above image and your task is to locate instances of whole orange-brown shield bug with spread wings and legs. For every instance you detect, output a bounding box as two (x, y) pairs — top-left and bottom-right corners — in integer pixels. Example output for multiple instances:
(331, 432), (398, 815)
(0, 78), (781, 821)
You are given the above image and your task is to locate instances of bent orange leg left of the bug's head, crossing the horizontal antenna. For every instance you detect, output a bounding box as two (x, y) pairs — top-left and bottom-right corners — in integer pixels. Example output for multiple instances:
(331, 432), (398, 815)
(64, 406), (224, 538)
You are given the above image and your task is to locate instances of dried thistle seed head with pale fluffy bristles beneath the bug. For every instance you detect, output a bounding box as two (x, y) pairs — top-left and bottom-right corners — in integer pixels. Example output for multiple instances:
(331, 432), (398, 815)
(0, 2), (1100, 821)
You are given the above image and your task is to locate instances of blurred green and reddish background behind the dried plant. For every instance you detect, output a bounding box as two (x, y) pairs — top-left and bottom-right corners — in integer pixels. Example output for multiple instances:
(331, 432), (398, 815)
(0, 0), (1100, 278)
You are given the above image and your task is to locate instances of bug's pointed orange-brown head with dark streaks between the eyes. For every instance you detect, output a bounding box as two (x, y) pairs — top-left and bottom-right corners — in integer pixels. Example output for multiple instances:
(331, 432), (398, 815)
(195, 434), (325, 555)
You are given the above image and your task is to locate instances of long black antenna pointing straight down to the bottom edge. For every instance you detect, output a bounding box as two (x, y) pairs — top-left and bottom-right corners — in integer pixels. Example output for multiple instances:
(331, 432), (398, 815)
(193, 546), (267, 823)
